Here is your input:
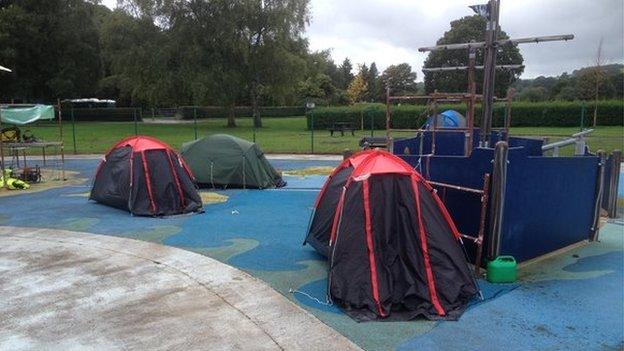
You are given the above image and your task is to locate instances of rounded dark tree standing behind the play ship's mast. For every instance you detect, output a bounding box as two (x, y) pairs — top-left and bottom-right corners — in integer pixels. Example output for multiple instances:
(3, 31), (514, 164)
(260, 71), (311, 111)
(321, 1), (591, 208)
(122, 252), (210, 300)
(424, 15), (524, 96)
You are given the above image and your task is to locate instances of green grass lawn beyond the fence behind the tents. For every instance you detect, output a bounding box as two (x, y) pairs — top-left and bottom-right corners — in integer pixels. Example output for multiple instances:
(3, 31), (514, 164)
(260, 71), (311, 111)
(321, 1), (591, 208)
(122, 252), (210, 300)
(17, 117), (623, 154)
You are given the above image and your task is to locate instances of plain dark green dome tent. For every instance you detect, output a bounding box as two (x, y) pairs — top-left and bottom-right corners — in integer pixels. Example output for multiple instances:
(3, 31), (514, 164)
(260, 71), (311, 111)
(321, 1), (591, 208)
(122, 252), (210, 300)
(181, 134), (286, 189)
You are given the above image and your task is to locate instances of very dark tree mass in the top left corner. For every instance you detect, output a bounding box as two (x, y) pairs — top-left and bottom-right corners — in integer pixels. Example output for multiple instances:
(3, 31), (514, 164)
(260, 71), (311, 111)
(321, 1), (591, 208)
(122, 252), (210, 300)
(0, 0), (101, 102)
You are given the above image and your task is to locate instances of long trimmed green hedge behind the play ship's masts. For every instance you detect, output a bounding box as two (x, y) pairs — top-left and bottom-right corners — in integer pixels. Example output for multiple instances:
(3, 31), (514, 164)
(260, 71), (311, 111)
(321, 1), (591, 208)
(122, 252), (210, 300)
(307, 100), (624, 129)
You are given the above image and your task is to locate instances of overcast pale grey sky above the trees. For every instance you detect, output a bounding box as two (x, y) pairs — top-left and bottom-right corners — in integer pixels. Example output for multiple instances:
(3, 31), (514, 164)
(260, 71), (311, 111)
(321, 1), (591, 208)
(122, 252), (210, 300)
(103, 0), (624, 81)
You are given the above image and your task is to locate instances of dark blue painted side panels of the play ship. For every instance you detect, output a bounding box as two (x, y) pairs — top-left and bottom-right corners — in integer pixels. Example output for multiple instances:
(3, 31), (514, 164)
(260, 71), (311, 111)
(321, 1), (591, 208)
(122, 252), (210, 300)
(395, 142), (598, 261)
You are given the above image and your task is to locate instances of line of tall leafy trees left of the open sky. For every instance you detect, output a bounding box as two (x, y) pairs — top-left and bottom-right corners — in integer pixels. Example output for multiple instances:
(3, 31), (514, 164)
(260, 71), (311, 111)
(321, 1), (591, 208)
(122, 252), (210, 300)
(0, 0), (416, 125)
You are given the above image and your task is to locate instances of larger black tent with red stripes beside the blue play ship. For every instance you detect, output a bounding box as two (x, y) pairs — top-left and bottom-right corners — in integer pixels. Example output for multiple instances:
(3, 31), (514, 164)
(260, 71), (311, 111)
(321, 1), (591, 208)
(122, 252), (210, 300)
(306, 150), (478, 321)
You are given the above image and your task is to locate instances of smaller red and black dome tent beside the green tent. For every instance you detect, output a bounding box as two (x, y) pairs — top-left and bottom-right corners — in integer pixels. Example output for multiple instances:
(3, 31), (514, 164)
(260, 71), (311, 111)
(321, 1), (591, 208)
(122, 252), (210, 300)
(89, 136), (202, 216)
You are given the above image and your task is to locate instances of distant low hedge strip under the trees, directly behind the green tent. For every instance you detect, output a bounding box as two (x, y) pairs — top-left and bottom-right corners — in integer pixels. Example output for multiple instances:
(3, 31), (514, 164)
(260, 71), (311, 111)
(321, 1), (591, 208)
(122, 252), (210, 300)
(176, 106), (305, 119)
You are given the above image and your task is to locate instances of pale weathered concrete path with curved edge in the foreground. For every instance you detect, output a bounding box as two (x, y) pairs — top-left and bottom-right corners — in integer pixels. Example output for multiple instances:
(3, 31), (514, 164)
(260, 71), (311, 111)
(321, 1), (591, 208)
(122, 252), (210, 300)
(0, 226), (359, 350)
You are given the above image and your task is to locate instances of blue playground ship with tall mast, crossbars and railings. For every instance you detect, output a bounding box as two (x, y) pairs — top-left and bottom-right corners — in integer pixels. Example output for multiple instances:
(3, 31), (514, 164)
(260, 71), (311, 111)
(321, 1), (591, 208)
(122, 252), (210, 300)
(386, 0), (621, 269)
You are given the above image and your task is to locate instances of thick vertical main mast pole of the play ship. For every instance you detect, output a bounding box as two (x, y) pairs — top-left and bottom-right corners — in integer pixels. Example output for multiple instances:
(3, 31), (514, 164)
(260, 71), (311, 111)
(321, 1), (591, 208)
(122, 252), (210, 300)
(480, 0), (500, 147)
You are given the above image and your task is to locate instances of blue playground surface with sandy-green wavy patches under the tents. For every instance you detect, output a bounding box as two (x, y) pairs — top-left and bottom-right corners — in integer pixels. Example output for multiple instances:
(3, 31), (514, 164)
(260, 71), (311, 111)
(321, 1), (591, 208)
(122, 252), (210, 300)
(0, 159), (624, 350)
